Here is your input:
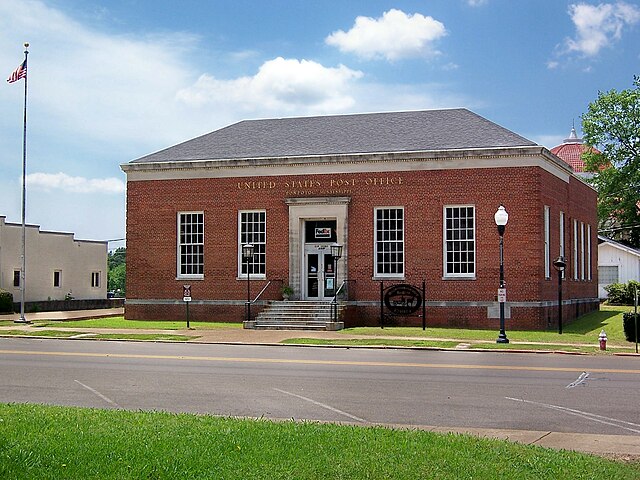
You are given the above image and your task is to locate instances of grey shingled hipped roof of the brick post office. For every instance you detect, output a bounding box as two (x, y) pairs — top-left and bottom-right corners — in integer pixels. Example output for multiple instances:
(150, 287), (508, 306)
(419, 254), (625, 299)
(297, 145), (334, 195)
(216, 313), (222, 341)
(131, 108), (536, 163)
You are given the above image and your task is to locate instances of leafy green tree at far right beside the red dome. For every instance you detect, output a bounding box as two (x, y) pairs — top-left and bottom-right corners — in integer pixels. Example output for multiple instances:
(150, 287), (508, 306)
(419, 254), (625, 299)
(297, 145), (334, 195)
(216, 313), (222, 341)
(582, 76), (640, 248)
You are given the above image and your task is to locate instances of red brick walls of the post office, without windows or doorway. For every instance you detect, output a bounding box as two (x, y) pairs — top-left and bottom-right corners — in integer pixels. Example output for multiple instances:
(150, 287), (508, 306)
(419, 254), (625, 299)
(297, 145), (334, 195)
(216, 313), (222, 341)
(126, 163), (597, 328)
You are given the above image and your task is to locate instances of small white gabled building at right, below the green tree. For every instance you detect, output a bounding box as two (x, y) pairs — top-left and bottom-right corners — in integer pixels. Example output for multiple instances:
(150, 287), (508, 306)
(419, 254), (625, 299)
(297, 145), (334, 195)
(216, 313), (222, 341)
(598, 235), (640, 298)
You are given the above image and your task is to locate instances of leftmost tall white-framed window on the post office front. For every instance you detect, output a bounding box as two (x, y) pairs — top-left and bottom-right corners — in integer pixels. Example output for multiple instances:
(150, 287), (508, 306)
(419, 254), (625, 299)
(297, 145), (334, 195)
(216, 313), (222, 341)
(178, 212), (204, 278)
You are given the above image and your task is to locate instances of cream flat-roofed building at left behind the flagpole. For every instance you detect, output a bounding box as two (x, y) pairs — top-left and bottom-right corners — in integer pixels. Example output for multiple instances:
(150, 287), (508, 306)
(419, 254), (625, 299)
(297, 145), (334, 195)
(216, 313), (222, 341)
(0, 216), (107, 302)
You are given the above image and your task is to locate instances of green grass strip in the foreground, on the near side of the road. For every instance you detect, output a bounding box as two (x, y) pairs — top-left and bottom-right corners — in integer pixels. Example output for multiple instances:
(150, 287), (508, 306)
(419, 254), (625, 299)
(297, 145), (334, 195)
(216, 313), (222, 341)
(0, 404), (640, 480)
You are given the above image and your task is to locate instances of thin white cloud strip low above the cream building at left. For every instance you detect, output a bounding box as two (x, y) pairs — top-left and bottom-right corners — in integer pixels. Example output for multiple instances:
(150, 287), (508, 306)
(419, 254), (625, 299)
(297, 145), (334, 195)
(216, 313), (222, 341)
(27, 172), (125, 194)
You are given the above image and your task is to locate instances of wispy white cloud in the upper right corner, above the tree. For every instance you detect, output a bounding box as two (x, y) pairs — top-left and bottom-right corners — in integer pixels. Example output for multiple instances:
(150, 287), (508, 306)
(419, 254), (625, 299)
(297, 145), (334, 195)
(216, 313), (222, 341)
(564, 2), (640, 57)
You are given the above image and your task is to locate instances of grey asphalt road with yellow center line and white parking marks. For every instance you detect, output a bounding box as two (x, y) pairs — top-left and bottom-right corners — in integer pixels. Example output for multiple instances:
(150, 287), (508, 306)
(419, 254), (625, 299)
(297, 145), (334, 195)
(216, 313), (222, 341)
(0, 339), (640, 436)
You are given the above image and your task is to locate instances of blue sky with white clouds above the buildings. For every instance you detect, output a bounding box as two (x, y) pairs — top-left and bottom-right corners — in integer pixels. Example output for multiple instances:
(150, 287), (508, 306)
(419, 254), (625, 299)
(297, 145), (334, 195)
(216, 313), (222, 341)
(0, 0), (640, 247)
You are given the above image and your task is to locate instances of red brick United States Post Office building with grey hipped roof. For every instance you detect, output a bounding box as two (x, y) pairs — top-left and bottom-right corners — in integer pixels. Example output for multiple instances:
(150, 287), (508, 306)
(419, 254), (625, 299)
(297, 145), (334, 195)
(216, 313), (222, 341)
(122, 109), (598, 329)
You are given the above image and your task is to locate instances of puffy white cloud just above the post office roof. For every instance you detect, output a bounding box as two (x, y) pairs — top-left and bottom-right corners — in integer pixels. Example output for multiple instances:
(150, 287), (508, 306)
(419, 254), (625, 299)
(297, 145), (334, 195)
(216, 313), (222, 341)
(177, 57), (362, 112)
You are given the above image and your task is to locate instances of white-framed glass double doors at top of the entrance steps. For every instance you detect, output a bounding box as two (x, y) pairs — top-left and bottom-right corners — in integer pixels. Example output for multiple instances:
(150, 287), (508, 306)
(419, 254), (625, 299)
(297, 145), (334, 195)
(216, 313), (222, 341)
(304, 245), (337, 300)
